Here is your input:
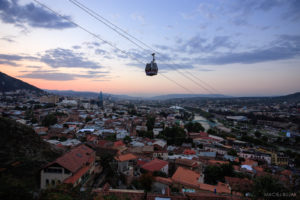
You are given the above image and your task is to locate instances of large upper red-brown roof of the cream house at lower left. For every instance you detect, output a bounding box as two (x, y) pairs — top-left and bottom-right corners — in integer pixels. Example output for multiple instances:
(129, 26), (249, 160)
(47, 144), (95, 173)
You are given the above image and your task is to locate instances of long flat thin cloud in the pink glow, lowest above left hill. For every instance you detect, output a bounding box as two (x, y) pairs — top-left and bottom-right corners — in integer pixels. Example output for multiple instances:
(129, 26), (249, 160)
(18, 70), (107, 81)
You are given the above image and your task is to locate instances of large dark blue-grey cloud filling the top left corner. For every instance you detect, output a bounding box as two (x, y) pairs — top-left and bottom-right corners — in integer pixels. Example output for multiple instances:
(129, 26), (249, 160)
(0, 0), (74, 29)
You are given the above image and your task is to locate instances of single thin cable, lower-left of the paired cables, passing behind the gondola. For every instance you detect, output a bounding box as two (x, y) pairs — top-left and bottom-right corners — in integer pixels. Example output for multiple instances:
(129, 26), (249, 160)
(33, 0), (195, 94)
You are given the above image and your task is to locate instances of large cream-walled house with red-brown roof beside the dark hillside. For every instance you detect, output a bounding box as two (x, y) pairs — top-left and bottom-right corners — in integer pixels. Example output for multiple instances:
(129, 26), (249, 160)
(40, 144), (96, 189)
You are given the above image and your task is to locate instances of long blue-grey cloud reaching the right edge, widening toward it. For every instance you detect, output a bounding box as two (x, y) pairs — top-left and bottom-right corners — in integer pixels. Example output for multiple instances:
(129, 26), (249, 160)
(197, 35), (300, 65)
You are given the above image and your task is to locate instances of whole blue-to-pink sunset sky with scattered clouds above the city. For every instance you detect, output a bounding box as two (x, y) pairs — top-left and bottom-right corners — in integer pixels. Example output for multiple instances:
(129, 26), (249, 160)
(0, 0), (300, 96)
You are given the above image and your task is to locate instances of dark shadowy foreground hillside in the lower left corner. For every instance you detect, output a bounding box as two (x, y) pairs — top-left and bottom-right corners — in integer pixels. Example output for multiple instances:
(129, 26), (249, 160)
(0, 117), (59, 199)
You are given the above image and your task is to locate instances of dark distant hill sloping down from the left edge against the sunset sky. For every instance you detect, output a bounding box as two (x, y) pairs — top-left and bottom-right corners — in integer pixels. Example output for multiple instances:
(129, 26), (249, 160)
(0, 72), (43, 92)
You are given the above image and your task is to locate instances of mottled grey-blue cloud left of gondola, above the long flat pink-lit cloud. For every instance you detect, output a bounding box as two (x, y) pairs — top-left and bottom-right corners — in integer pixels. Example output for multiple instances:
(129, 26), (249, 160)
(40, 48), (102, 69)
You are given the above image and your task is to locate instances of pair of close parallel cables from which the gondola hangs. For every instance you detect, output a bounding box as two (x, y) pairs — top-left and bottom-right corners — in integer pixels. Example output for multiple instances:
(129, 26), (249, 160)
(69, 0), (219, 94)
